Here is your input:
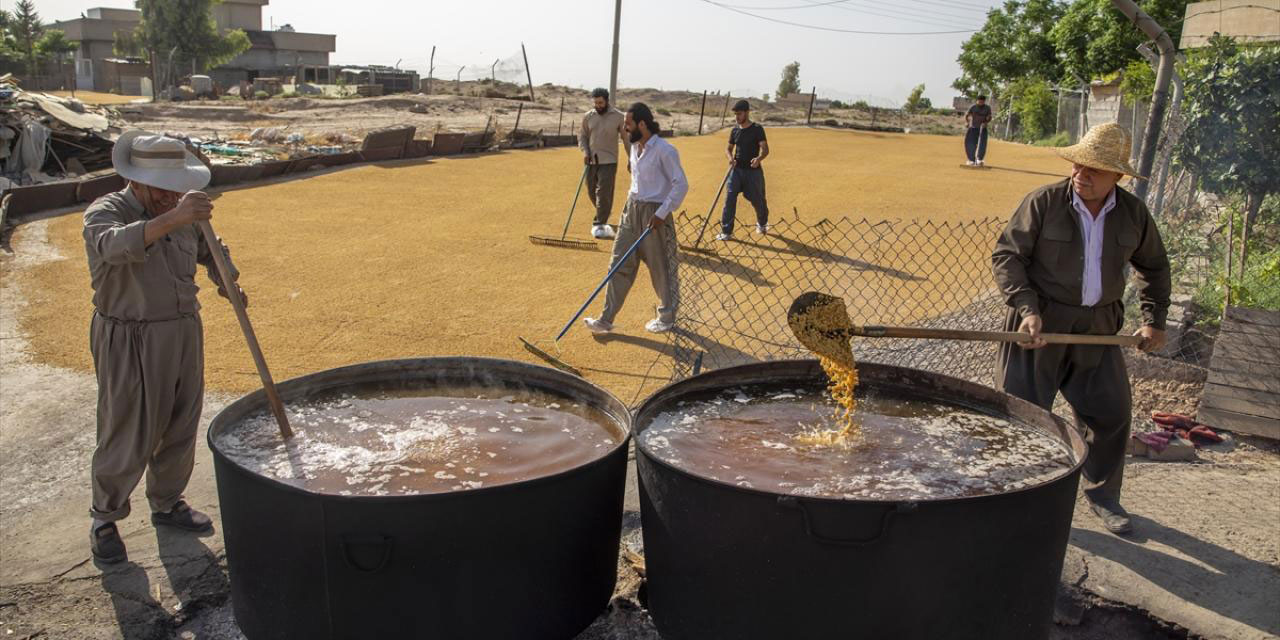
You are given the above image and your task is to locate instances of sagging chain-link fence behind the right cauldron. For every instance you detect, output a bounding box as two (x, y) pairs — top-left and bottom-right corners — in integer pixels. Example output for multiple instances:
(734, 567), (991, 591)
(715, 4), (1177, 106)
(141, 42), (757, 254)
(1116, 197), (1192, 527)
(673, 209), (1208, 384)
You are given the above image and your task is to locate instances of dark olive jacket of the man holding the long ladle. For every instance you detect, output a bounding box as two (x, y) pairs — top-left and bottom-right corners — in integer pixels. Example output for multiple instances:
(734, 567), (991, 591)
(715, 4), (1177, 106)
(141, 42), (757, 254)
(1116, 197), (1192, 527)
(991, 179), (1171, 329)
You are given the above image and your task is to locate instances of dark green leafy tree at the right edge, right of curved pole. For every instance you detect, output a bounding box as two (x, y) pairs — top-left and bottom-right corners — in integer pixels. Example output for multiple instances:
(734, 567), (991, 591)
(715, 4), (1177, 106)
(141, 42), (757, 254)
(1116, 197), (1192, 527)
(1176, 35), (1280, 268)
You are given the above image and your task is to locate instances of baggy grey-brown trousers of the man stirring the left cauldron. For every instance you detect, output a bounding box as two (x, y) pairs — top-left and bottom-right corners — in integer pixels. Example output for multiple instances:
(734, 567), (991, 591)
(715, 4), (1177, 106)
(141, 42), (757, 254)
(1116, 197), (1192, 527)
(90, 314), (205, 522)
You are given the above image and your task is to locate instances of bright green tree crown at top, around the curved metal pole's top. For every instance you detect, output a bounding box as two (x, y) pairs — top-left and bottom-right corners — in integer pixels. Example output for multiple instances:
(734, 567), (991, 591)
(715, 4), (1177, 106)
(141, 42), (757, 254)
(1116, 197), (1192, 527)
(1050, 0), (1189, 79)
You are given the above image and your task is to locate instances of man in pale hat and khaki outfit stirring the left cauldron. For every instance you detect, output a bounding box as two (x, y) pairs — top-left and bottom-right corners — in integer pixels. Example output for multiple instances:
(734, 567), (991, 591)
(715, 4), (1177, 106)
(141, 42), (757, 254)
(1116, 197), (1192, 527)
(84, 131), (243, 563)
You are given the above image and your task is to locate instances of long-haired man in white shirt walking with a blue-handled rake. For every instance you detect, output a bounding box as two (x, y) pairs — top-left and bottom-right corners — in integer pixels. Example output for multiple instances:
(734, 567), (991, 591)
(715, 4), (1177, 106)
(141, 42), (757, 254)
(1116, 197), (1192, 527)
(582, 102), (689, 334)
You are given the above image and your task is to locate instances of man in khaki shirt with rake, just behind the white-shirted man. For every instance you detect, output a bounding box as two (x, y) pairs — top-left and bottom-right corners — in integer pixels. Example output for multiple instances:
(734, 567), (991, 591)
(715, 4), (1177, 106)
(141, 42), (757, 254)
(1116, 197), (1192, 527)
(577, 88), (631, 238)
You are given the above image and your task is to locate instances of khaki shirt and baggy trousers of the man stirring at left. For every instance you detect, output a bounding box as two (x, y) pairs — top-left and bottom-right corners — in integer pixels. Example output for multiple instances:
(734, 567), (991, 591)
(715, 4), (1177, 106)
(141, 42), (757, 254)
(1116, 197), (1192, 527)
(83, 132), (234, 522)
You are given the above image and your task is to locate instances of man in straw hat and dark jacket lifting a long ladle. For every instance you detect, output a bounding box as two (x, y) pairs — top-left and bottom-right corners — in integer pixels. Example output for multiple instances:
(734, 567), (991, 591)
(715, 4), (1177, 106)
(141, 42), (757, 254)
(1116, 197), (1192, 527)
(991, 124), (1170, 534)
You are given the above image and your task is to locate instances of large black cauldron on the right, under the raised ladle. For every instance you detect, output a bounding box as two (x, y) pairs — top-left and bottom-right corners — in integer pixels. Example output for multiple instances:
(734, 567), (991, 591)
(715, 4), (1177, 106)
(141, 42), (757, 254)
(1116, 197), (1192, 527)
(635, 361), (1085, 640)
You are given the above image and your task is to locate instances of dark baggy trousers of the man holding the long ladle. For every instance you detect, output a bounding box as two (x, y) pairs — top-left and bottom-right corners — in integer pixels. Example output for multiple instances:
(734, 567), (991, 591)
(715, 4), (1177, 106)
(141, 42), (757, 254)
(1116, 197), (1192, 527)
(996, 298), (1133, 504)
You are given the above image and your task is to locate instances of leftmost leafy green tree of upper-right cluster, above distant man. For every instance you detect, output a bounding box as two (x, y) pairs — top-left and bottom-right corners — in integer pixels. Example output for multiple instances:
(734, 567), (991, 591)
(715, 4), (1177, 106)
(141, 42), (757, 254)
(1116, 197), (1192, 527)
(951, 0), (1066, 97)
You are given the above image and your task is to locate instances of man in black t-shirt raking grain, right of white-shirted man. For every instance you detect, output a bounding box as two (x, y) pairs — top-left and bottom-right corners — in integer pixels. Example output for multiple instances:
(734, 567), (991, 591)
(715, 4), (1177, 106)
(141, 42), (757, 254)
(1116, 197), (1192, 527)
(716, 100), (769, 241)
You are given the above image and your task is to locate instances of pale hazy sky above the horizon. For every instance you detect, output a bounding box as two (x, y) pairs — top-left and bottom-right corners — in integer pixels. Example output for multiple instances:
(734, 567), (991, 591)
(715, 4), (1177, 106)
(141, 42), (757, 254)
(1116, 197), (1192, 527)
(22, 0), (1000, 104)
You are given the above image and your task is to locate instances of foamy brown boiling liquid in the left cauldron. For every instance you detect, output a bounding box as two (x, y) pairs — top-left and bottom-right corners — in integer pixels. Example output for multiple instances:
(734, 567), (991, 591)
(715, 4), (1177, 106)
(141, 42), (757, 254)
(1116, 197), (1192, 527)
(215, 388), (622, 495)
